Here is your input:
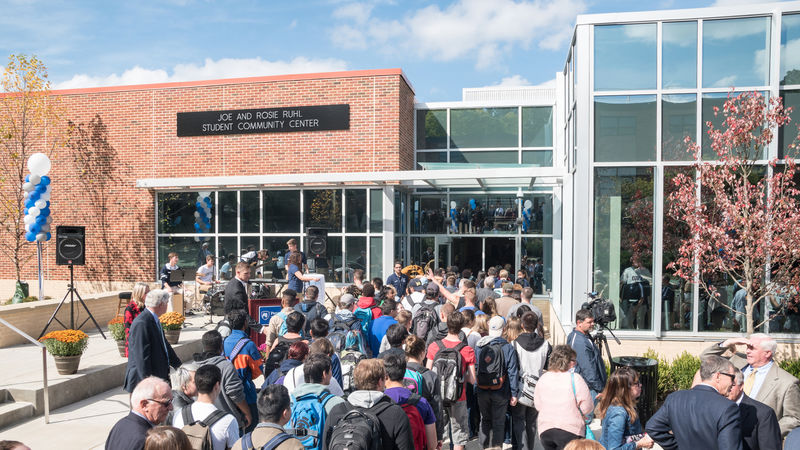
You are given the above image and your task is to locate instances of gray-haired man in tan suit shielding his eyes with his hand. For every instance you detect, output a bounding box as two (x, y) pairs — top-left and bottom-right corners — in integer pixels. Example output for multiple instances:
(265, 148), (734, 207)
(700, 333), (800, 437)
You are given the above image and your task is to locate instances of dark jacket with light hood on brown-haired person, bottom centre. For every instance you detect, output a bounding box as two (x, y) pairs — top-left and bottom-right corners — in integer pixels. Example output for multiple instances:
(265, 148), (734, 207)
(322, 391), (414, 450)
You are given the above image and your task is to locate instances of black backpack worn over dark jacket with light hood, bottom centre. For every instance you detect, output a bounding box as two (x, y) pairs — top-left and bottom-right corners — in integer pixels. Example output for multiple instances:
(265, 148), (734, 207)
(327, 402), (392, 450)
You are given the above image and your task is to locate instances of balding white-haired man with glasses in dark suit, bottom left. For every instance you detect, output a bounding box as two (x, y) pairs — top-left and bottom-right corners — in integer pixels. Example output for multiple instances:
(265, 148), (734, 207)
(105, 377), (172, 450)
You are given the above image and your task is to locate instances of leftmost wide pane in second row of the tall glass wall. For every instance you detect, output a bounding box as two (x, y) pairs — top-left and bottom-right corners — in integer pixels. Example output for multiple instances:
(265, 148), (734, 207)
(594, 95), (656, 162)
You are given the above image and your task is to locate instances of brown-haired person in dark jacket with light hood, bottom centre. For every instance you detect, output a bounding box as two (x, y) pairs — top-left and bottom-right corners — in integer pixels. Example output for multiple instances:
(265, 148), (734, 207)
(323, 358), (414, 450)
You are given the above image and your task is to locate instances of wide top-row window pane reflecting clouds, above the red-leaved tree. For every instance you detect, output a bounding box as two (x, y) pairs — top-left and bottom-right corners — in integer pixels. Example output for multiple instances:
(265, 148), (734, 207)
(703, 17), (770, 88)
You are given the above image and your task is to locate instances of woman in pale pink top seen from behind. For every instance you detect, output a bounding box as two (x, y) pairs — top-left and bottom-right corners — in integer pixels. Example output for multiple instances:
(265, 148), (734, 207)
(533, 345), (594, 450)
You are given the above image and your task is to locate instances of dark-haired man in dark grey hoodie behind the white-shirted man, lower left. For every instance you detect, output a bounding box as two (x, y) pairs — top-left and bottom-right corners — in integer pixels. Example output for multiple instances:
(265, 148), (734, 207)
(194, 330), (252, 430)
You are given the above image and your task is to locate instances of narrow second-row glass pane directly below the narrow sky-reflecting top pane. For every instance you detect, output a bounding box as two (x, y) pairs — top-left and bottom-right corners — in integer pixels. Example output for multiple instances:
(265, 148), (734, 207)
(661, 94), (697, 161)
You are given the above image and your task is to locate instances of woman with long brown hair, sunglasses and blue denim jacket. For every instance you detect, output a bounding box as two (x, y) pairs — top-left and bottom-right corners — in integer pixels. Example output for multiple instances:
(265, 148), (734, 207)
(595, 367), (653, 450)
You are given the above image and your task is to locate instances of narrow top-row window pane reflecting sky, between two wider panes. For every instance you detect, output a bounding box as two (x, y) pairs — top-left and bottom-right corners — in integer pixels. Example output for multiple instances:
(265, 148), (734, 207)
(661, 22), (697, 89)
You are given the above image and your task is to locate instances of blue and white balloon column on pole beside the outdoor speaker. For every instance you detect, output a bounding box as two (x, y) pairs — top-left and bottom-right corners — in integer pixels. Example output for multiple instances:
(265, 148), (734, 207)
(22, 153), (53, 242)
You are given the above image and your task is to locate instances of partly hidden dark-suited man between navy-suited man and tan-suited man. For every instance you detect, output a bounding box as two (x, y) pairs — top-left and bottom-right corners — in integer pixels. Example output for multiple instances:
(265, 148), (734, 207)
(728, 369), (782, 450)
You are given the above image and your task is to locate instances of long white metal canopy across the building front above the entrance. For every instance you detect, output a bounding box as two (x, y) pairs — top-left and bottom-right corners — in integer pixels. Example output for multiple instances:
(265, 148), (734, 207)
(136, 167), (566, 190)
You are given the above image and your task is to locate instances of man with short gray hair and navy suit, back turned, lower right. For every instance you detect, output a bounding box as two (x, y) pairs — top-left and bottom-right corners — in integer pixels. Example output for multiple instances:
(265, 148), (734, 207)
(647, 356), (742, 450)
